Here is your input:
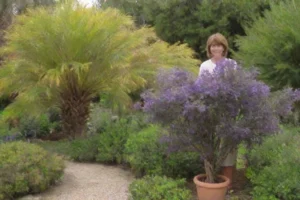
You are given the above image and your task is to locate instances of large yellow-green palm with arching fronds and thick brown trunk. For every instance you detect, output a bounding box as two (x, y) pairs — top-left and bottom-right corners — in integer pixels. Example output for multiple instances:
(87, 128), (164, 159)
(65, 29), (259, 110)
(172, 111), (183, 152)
(0, 1), (197, 137)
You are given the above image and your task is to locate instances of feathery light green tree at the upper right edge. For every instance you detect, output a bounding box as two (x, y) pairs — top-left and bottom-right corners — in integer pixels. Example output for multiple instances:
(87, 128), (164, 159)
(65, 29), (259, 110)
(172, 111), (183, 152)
(235, 0), (300, 89)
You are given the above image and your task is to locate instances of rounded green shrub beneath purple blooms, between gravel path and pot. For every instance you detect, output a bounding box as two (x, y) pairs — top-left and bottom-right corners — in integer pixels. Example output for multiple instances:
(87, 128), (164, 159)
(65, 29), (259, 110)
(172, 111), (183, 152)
(125, 125), (203, 178)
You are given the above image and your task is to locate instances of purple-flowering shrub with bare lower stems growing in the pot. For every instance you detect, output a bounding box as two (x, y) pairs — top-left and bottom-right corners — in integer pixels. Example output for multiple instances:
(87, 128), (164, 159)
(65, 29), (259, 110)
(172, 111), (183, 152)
(142, 59), (300, 182)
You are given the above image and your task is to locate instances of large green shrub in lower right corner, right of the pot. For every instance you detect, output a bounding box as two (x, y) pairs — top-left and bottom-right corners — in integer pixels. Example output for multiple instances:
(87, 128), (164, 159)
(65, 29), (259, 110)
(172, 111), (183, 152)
(247, 128), (300, 200)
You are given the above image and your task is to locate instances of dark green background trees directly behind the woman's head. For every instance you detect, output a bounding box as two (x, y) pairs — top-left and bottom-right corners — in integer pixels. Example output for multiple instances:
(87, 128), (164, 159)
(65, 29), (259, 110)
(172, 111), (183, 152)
(99, 0), (280, 60)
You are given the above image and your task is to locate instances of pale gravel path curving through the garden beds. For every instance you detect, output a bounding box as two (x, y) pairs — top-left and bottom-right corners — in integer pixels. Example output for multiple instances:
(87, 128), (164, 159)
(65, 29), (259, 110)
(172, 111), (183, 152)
(19, 162), (134, 200)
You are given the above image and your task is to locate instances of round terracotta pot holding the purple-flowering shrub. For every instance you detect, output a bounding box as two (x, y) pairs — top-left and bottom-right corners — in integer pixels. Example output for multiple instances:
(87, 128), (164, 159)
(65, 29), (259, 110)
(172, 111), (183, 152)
(194, 174), (230, 200)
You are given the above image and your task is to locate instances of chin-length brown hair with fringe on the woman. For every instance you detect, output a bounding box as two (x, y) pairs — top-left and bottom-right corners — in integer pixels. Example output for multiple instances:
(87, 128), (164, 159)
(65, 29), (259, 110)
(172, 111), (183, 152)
(206, 33), (228, 58)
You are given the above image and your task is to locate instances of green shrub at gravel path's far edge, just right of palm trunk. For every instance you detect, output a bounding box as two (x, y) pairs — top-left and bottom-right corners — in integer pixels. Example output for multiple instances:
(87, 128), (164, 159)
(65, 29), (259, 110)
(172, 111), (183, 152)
(96, 118), (135, 163)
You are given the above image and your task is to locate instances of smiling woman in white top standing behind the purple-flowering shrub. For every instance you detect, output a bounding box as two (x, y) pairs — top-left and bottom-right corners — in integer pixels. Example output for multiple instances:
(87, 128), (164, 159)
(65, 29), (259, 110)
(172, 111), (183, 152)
(199, 33), (237, 188)
